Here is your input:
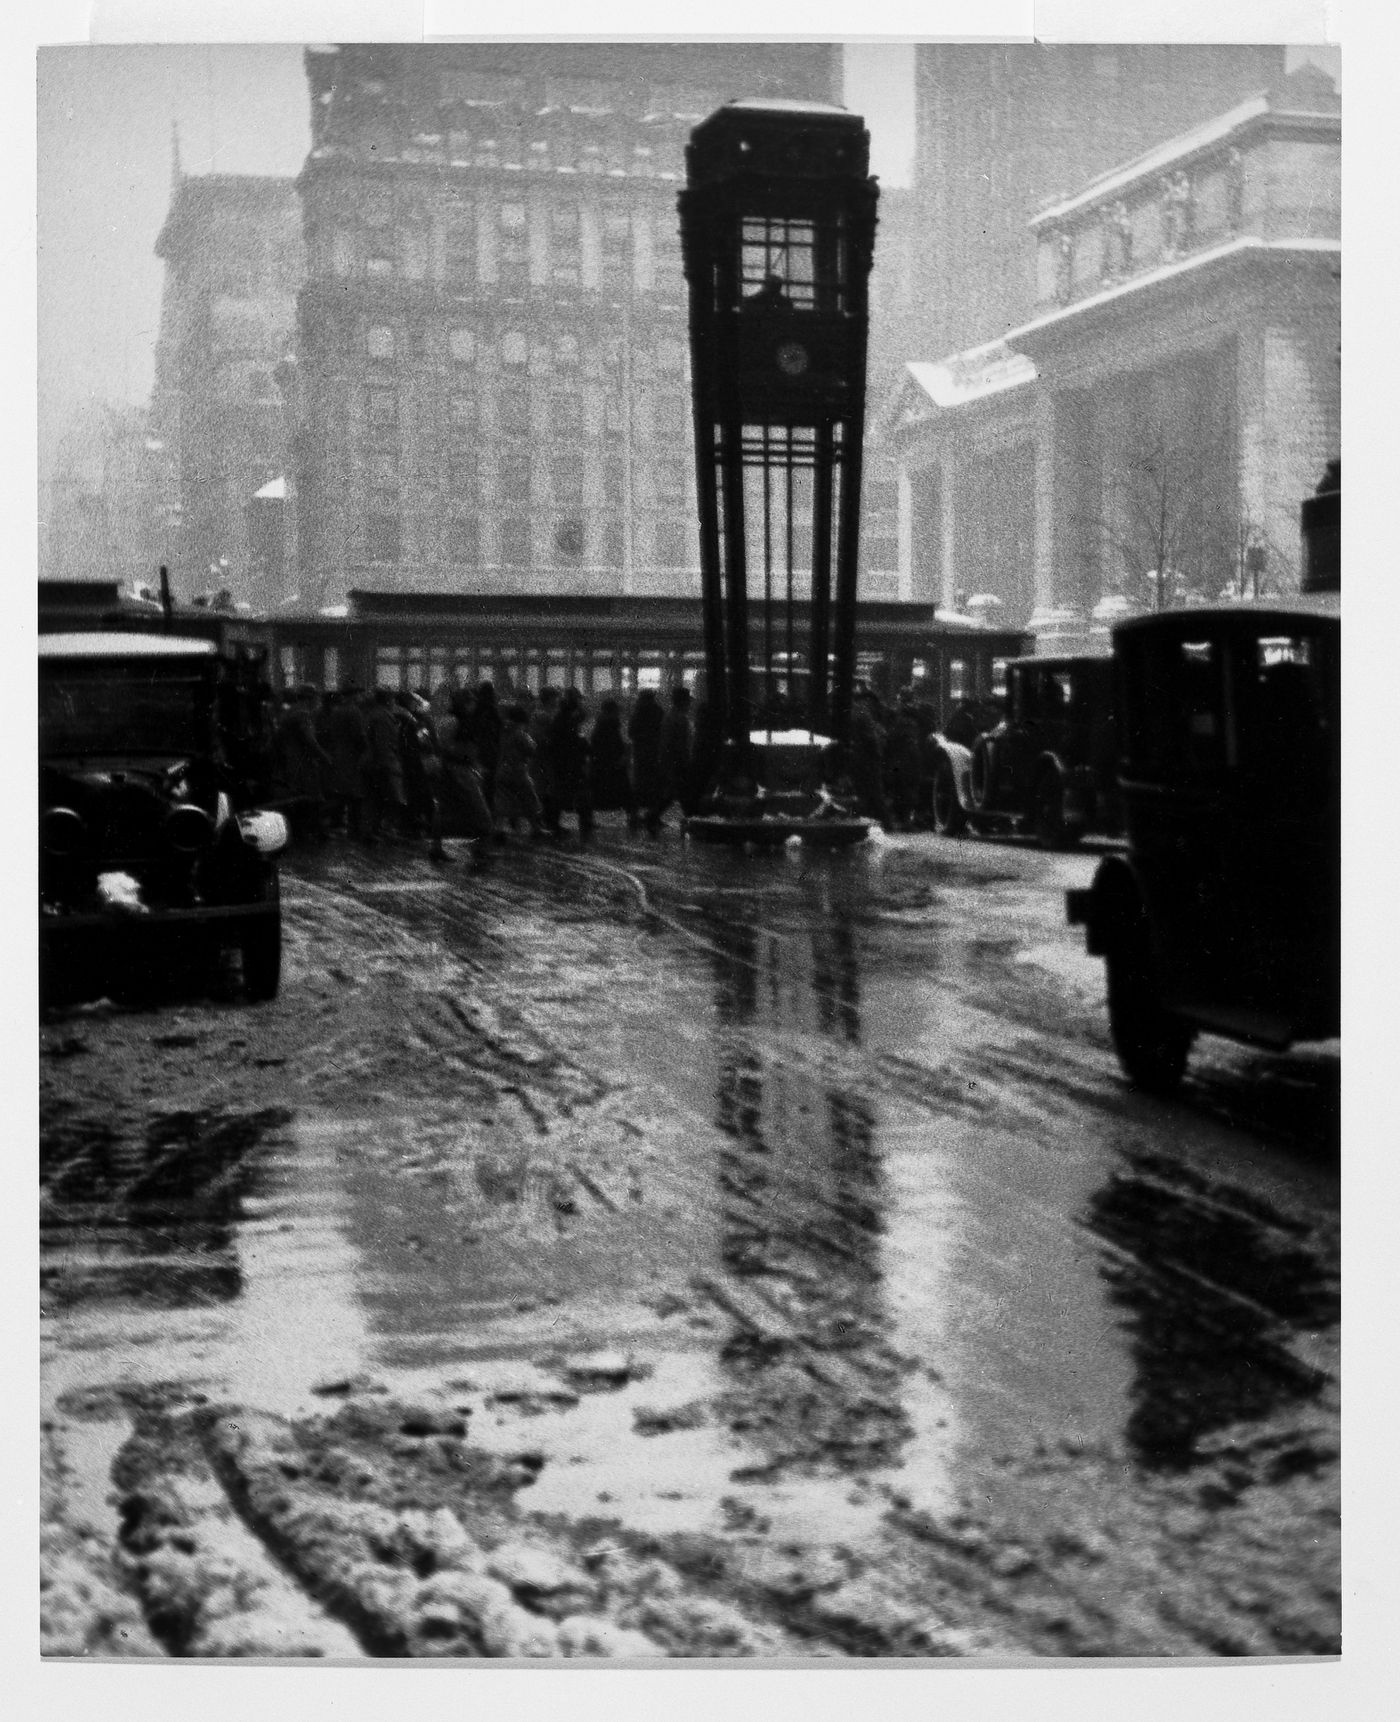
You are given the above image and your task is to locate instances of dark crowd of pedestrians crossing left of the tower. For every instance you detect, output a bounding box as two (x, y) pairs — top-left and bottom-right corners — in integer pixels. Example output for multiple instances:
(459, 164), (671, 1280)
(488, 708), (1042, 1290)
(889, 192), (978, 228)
(270, 682), (701, 863)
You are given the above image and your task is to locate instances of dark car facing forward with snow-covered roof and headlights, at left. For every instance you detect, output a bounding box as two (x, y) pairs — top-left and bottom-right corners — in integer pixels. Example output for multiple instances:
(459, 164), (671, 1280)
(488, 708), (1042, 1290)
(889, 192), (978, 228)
(40, 632), (288, 999)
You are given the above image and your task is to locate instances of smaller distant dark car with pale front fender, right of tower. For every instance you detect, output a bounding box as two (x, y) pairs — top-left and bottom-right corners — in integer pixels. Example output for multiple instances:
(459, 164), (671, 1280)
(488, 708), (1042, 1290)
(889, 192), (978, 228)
(932, 656), (1121, 849)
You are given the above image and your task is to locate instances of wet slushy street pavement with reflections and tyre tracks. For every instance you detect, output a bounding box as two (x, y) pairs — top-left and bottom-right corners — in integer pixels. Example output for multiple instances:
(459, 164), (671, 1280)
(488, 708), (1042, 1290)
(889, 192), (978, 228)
(41, 830), (1340, 1657)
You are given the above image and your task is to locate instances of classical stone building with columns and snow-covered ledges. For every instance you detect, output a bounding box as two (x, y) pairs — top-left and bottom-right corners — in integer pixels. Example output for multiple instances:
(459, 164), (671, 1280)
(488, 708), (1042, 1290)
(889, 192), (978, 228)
(883, 65), (1341, 649)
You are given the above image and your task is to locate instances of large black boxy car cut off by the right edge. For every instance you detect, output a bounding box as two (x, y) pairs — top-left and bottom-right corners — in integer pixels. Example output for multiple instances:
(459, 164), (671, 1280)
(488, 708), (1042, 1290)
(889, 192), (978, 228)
(1068, 594), (1341, 1092)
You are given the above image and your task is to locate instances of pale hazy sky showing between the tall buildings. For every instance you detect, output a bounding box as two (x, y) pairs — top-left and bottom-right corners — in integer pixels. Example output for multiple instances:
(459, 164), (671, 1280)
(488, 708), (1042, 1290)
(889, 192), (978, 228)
(38, 45), (914, 475)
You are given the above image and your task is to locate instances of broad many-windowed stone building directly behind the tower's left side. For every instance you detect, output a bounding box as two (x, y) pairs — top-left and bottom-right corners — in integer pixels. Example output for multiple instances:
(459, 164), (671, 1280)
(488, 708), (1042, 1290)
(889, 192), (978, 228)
(289, 43), (840, 604)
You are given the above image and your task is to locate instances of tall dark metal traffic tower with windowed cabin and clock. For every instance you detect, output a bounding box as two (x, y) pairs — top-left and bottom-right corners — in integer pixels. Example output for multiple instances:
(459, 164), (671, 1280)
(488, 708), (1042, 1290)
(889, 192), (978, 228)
(680, 100), (878, 840)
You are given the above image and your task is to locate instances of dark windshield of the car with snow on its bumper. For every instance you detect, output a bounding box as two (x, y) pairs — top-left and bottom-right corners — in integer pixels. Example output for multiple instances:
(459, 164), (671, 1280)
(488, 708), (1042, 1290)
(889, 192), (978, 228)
(40, 661), (214, 756)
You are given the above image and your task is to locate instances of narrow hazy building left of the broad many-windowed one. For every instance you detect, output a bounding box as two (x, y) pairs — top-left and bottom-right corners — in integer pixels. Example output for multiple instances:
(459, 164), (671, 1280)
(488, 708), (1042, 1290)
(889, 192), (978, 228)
(150, 165), (303, 608)
